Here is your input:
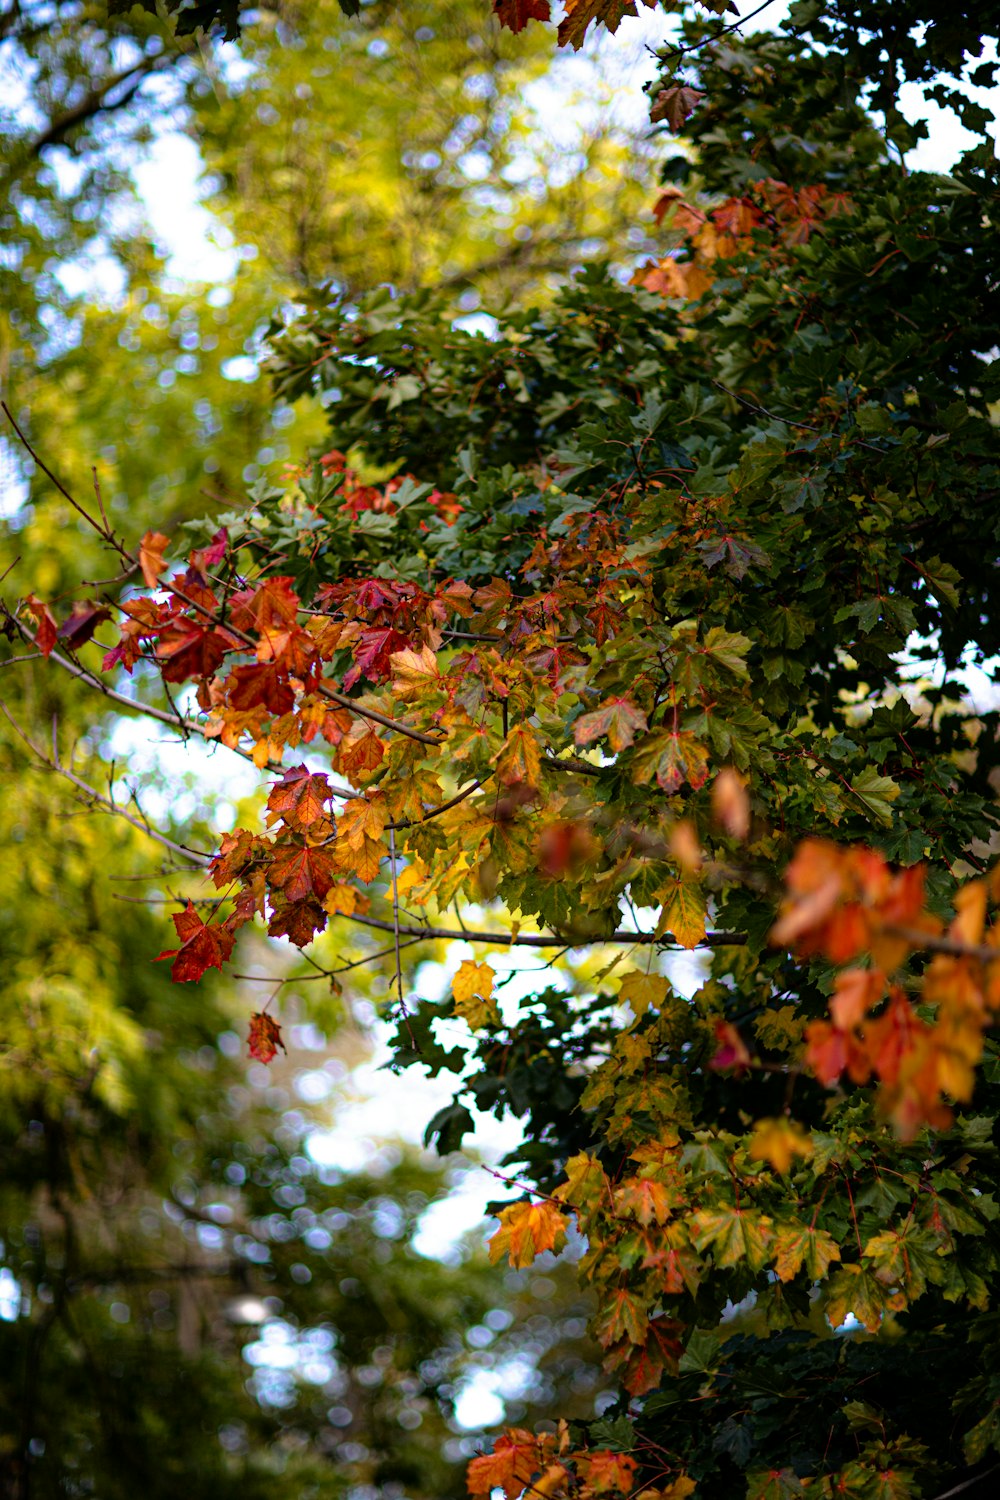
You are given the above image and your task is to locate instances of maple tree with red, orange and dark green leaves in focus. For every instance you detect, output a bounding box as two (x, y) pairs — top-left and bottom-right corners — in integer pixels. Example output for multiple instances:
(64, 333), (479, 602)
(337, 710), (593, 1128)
(10, 3), (1000, 1500)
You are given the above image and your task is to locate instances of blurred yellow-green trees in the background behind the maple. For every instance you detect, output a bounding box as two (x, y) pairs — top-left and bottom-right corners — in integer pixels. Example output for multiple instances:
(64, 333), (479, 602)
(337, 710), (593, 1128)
(0, 0), (652, 1500)
